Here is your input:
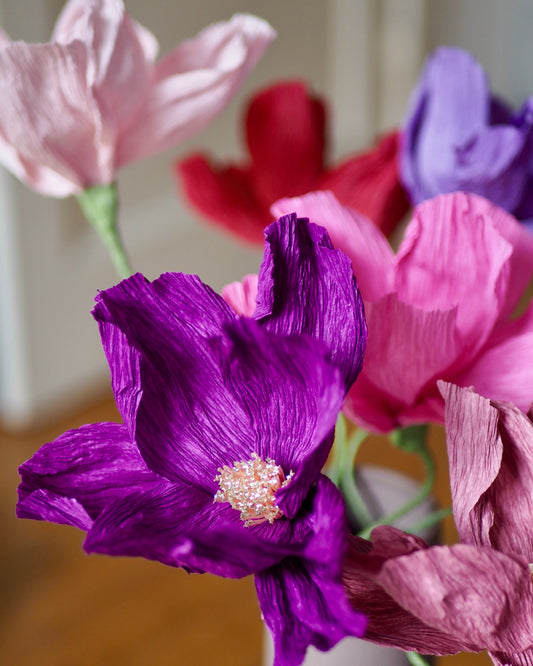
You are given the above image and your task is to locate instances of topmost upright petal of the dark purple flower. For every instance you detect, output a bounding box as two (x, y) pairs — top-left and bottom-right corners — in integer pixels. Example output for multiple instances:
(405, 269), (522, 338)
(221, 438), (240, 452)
(254, 213), (366, 390)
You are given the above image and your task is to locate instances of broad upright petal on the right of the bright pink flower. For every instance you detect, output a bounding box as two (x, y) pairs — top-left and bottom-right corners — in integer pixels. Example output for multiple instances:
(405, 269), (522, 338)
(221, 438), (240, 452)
(396, 193), (512, 360)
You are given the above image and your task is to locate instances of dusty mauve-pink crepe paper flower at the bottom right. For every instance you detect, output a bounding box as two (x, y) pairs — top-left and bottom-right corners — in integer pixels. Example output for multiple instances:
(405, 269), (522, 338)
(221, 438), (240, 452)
(338, 382), (533, 666)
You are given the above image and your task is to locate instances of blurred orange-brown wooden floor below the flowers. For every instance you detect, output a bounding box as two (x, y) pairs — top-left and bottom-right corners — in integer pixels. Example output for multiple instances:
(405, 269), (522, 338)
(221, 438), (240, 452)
(0, 392), (490, 666)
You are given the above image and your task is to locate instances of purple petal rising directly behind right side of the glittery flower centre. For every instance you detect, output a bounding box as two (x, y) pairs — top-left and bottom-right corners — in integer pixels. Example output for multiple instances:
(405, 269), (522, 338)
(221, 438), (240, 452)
(210, 319), (344, 518)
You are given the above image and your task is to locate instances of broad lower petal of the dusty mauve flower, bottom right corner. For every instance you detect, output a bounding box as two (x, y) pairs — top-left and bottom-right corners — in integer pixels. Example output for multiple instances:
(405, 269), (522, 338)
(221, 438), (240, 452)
(376, 544), (533, 652)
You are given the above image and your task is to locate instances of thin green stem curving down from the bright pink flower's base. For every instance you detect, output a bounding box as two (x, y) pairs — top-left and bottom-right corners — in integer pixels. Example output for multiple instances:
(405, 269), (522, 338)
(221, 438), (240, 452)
(359, 426), (435, 539)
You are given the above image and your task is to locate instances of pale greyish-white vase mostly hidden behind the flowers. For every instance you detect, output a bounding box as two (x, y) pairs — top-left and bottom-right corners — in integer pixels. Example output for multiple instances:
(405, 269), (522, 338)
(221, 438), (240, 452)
(263, 465), (438, 666)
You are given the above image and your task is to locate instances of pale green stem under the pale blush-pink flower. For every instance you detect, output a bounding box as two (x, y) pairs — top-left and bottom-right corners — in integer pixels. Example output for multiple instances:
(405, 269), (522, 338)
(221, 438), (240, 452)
(77, 183), (133, 279)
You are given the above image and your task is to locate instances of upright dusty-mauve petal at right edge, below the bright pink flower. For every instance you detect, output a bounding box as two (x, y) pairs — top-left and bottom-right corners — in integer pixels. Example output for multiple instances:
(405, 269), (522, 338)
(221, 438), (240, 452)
(440, 384), (533, 562)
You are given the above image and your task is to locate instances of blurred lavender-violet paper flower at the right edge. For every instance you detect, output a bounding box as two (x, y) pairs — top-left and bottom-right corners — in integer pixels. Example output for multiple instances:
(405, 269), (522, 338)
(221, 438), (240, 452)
(400, 48), (533, 228)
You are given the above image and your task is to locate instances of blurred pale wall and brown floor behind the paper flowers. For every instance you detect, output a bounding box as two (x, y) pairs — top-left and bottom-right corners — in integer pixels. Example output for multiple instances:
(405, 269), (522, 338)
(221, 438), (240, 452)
(0, 0), (533, 666)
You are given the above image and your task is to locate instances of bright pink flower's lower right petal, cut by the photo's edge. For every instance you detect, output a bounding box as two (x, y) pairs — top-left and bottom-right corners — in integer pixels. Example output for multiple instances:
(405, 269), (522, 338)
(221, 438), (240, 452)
(453, 306), (533, 412)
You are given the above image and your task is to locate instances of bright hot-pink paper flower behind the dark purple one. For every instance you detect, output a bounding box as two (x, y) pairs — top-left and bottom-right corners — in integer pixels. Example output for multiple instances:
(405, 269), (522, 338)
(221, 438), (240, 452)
(273, 193), (533, 432)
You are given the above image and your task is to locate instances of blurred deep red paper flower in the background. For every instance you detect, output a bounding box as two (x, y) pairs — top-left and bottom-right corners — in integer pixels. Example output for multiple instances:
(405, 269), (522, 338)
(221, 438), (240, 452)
(176, 81), (409, 243)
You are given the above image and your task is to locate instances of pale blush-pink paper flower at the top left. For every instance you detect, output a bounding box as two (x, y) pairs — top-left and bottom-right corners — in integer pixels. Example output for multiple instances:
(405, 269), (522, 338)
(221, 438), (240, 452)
(0, 0), (275, 197)
